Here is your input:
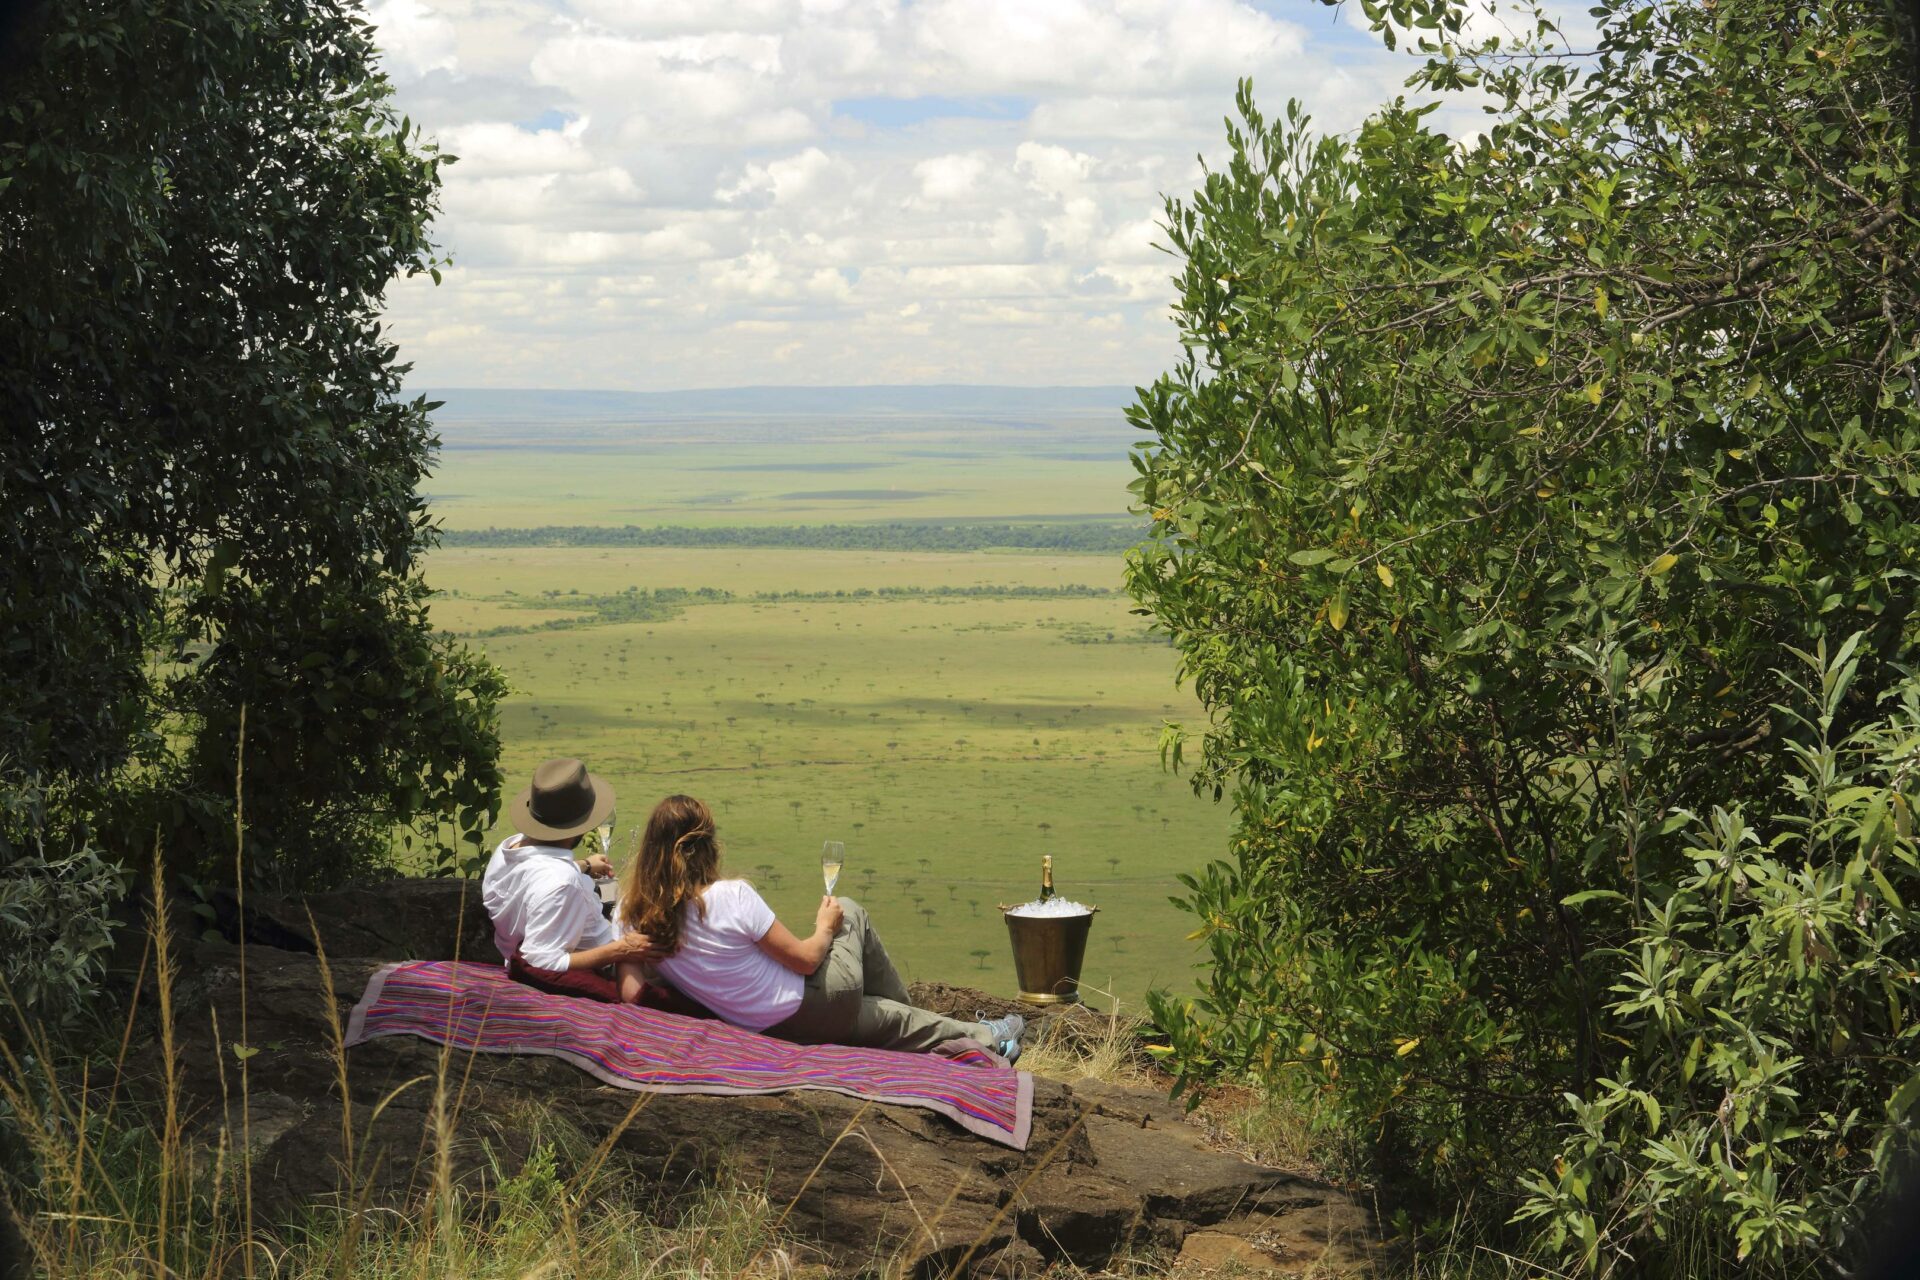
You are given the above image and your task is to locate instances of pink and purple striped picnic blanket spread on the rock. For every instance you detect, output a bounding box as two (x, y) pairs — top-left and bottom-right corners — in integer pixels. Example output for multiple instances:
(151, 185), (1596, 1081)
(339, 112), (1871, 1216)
(348, 960), (1033, 1151)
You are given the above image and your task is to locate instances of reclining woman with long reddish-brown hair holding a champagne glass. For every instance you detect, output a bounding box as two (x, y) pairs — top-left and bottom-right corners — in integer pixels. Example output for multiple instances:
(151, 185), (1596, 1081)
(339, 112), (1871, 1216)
(616, 796), (1025, 1061)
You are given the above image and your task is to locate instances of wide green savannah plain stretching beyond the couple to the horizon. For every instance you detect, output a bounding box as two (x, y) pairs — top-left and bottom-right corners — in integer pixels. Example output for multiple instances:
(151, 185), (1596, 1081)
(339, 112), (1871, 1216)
(428, 391), (1229, 1007)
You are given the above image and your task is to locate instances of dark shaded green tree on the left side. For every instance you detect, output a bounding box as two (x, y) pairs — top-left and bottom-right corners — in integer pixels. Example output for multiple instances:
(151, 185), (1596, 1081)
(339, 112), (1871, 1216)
(0, 0), (501, 901)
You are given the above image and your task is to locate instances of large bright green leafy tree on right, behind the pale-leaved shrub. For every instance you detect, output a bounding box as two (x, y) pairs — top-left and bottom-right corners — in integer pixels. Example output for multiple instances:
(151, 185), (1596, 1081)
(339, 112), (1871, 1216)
(1129, 0), (1920, 1268)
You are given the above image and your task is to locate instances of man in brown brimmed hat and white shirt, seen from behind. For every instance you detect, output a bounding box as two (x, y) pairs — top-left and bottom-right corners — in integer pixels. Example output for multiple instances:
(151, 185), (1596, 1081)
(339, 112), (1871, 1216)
(480, 760), (657, 1004)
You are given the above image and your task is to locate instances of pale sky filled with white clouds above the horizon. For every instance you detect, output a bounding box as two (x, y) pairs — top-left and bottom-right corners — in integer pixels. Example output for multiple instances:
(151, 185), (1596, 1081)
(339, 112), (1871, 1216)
(371, 0), (1497, 391)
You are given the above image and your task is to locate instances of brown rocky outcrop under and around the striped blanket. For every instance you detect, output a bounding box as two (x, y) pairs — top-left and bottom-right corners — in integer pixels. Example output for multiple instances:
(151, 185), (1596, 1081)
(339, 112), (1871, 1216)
(119, 881), (1371, 1276)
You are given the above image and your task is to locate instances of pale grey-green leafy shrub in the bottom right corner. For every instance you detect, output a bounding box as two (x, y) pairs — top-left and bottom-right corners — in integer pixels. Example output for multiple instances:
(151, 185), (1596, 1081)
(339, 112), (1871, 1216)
(1521, 635), (1920, 1274)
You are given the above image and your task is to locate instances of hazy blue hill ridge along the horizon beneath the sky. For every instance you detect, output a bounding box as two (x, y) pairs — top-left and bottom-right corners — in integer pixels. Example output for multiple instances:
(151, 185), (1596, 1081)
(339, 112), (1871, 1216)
(420, 384), (1135, 422)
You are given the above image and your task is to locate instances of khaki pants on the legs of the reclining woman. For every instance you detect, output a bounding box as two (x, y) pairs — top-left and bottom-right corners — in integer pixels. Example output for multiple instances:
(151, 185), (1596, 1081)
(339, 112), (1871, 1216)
(766, 898), (993, 1054)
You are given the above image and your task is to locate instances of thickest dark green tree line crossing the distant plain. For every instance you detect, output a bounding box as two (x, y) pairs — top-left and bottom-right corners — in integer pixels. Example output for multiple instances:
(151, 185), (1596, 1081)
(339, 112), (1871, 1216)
(442, 520), (1146, 553)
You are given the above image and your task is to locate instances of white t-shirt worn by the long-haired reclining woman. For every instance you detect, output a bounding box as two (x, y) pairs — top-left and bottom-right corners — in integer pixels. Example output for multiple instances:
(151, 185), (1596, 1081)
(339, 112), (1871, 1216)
(622, 881), (806, 1031)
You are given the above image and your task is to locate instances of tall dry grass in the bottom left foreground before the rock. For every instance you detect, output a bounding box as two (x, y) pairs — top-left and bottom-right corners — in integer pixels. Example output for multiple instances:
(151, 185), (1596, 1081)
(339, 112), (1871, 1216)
(0, 860), (817, 1280)
